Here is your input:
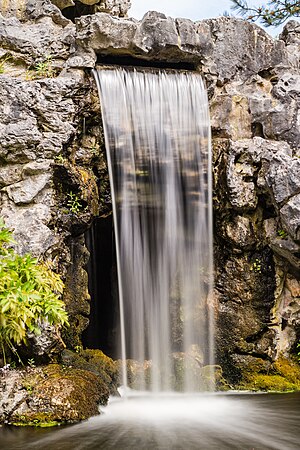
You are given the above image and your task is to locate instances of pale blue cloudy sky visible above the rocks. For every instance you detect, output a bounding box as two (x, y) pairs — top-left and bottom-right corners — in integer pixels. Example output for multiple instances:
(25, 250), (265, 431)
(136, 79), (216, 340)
(129, 0), (282, 36)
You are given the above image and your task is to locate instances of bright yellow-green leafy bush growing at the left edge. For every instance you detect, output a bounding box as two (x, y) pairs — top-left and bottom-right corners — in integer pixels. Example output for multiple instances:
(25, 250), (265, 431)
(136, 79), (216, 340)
(0, 219), (68, 363)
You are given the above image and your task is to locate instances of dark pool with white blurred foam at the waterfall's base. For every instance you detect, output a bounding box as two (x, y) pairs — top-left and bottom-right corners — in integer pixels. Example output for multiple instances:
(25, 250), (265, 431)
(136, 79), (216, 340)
(0, 393), (300, 450)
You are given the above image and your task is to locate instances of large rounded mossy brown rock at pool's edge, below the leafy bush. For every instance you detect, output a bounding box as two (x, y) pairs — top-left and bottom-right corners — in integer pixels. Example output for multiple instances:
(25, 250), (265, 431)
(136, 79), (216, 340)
(6, 364), (109, 427)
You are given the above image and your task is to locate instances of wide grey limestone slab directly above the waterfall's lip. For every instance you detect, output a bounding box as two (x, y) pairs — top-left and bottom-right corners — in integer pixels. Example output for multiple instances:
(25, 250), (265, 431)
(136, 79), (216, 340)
(76, 11), (204, 62)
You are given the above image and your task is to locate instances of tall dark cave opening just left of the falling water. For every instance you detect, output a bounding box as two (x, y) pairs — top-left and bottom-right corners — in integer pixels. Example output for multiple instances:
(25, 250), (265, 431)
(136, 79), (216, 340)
(82, 215), (119, 358)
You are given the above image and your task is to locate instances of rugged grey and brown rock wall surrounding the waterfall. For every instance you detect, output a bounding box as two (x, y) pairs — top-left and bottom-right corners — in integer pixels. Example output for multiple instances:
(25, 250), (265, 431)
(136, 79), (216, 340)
(0, 0), (300, 382)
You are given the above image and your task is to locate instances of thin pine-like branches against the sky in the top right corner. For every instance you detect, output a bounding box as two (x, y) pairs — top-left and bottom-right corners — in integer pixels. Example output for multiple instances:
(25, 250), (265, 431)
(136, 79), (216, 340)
(231, 0), (300, 27)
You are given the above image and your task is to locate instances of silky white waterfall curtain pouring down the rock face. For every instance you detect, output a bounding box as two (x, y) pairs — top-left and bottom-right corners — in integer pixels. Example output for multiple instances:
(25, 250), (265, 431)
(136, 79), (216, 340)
(94, 68), (214, 392)
